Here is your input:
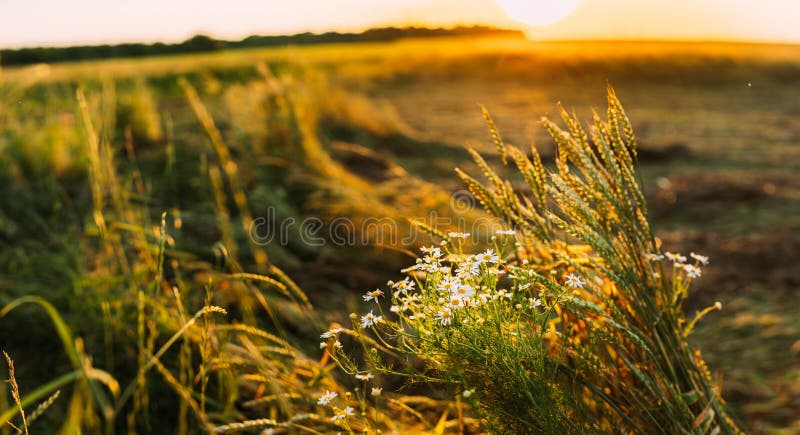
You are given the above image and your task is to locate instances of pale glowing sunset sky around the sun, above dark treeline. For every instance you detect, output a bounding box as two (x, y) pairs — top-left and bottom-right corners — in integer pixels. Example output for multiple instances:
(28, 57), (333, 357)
(0, 0), (800, 48)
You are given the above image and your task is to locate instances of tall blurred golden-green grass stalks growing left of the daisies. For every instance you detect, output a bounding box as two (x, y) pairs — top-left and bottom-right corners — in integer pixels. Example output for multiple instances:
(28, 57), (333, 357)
(0, 64), (460, 433)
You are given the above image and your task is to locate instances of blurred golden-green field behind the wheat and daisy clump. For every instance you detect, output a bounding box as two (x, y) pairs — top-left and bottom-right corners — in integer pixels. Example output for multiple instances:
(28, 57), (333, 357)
(0, 38), (800, 433)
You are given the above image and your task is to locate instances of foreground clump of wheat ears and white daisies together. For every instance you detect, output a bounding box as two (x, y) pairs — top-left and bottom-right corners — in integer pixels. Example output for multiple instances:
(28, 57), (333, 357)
(323, 89), (739, 433)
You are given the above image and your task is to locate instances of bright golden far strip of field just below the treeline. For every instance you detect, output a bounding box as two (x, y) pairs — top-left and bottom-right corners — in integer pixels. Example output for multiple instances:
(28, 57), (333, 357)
(1, 37), (800, 83)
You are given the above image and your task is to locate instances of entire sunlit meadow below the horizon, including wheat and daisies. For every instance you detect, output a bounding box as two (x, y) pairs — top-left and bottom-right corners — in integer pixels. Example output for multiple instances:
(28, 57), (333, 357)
(0, 11), (800, 434)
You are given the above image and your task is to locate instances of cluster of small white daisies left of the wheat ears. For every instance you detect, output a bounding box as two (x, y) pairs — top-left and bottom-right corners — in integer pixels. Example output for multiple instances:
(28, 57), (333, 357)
(320, 230), (592, 430)
